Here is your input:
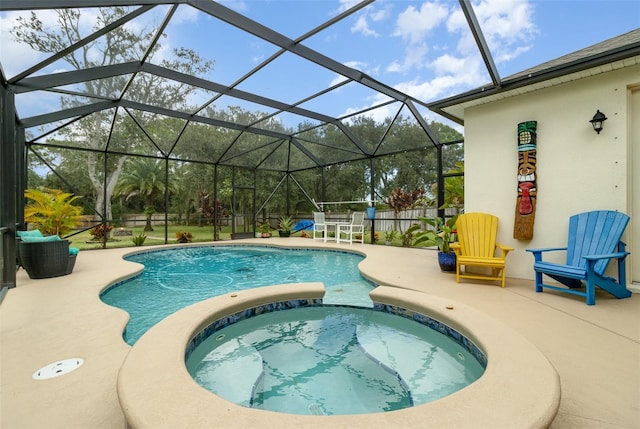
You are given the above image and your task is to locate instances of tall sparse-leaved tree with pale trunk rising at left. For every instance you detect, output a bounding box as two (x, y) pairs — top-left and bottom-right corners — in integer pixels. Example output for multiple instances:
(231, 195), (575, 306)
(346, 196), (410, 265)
(11, 7), (213, 224)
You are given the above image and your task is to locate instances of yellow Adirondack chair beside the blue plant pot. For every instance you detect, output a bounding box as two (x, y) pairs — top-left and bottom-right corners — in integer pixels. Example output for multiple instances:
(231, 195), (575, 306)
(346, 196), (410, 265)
(451, 213), (513, 287)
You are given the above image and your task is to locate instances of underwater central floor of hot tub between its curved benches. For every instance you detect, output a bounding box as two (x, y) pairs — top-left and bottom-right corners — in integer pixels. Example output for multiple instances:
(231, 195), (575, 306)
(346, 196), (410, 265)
(252, 315), (411, 415)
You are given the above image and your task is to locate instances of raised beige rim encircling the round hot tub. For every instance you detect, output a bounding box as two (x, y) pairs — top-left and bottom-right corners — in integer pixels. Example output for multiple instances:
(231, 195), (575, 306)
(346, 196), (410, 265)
(117, 283), (561, 429)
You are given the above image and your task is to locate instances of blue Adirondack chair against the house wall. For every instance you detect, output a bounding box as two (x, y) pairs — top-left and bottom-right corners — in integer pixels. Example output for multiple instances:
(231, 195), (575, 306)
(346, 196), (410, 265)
(527, 210), (631, 305)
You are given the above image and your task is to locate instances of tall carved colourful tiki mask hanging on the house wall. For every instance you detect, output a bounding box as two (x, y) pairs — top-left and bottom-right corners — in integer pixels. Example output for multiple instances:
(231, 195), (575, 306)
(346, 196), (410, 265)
(513, 121), (538, 240)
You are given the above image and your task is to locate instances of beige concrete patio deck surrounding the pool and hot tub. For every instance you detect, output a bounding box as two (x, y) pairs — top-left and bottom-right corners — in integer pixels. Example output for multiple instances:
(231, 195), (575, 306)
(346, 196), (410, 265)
(0, 238), (640, 429)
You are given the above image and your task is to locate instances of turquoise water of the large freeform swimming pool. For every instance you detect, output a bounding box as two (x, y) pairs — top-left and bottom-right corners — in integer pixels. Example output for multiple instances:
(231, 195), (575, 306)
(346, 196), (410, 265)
(101, 246), (375, 344)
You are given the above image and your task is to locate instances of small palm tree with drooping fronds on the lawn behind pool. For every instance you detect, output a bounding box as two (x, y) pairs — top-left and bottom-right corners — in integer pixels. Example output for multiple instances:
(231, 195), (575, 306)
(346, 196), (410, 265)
(115, 158), (175, 231)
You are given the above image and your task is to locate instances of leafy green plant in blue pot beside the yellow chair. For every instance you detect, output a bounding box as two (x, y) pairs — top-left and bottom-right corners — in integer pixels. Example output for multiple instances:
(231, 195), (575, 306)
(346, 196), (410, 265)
(414, 215), (458, 271)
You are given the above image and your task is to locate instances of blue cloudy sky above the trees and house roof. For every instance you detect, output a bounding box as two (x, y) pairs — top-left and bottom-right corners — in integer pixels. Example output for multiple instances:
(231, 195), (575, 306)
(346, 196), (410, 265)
(0, 0), (640, 131)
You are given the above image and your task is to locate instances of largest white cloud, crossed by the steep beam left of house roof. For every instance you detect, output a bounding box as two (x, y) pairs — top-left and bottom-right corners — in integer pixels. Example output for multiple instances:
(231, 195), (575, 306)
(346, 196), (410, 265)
(378, 0), (537, 104)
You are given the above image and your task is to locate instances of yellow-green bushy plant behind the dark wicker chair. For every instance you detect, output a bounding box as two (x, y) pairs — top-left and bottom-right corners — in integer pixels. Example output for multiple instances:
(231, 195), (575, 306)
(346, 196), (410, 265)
(24, 188), (82, 237)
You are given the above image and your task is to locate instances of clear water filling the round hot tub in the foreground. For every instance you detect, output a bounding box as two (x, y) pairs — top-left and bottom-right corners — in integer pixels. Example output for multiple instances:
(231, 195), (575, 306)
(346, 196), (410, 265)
(186, 306), (484, 415)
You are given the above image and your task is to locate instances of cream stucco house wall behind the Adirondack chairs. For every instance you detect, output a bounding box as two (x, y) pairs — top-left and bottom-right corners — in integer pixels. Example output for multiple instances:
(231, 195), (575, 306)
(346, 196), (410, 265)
(465, 65), (640, 283)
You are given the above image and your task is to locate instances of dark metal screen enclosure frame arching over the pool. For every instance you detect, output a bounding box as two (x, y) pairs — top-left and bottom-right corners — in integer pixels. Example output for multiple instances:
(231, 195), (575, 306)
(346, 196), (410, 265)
(0, 0), (500, 287)
